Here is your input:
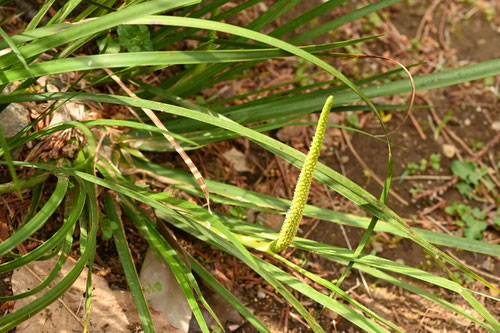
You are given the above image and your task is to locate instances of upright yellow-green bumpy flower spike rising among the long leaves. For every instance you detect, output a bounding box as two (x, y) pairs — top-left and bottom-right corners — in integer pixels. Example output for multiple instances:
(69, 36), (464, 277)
(269, 96), (333, 253)
